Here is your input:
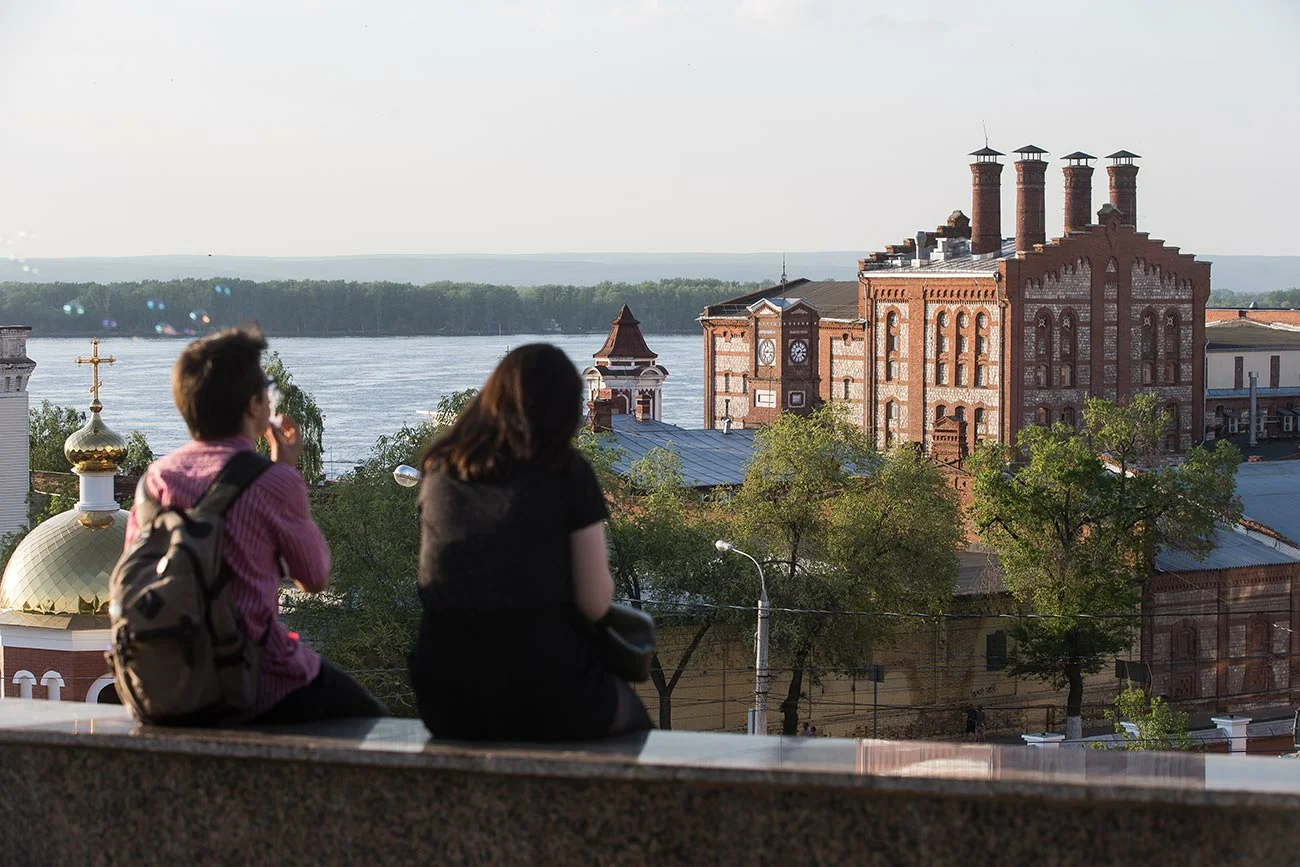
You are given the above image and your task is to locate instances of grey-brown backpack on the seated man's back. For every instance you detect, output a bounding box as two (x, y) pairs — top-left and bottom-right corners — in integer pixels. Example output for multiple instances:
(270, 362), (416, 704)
(105, 451), (270, 725)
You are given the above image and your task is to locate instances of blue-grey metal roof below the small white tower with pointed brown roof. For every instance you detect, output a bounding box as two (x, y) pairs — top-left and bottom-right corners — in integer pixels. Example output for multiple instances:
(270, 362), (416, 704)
(612, 413), (754, 487)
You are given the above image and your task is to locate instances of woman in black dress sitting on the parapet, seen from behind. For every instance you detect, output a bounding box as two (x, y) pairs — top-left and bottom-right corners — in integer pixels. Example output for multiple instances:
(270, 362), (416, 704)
(410, 343), (651, 741)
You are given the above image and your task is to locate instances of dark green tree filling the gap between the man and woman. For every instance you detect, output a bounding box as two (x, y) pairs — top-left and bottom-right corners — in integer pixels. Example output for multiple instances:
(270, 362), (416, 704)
(285, 389), (475, 715)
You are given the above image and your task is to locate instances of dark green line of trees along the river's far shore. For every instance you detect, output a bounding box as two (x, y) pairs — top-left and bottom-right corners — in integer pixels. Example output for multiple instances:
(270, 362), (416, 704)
(0, 278), (759, 337)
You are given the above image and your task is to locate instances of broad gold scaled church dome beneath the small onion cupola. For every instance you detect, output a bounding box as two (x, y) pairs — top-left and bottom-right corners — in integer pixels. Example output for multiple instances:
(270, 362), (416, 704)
(0, 501), (129, 615)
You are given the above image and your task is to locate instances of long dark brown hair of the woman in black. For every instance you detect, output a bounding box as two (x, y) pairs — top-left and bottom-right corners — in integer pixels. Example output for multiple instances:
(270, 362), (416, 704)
(423, 343), (582, 481)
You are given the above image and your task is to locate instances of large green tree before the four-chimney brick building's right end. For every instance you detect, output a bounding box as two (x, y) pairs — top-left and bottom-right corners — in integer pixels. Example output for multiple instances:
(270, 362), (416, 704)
(970, 394), (1242, 740)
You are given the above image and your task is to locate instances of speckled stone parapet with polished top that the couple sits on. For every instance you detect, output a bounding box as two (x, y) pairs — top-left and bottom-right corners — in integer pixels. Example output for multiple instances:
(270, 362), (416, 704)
(0, 699), (1300, 866)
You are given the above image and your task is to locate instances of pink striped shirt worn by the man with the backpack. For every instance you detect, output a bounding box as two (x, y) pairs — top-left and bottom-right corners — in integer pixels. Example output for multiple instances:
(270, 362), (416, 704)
(126, 434), (329, 719)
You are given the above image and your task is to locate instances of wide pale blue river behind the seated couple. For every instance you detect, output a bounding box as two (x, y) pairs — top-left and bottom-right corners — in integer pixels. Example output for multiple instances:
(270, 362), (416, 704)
(27, 334), (703, 474)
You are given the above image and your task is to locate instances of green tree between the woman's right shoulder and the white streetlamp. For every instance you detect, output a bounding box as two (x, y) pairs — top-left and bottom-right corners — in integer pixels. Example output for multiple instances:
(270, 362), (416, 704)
(579, 441), (757, 729)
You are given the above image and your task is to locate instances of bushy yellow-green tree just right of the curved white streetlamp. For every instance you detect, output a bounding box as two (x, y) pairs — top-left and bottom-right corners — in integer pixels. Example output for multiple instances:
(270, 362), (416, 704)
(735, 404), (961, 734)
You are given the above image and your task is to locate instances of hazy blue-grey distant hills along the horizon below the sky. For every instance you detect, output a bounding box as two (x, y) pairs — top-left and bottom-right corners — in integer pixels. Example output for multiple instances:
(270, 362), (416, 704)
(0, 251), (1300, 294)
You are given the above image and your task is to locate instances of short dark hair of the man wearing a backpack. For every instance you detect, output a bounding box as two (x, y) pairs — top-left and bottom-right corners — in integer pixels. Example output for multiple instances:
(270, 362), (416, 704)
(172, 328), (267, 439)
